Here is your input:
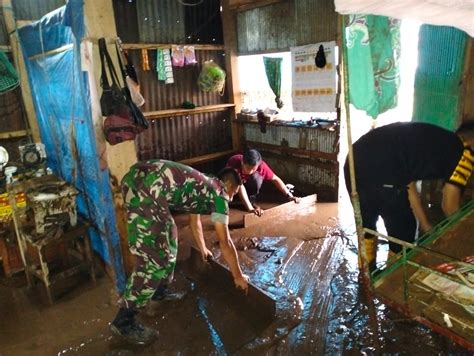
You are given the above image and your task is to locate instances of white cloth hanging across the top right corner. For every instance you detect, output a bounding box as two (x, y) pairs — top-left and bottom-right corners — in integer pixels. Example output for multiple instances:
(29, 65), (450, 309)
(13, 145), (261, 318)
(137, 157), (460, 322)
(335, 0), (474, 37)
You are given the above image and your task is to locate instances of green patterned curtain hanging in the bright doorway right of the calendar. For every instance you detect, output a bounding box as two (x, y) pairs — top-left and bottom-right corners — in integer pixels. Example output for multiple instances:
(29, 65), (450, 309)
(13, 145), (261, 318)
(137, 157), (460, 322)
(344, 15), (400, 119)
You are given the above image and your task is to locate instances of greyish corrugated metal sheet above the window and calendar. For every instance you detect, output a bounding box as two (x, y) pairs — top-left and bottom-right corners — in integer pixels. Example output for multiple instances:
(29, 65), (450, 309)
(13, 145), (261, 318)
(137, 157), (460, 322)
(237, 0), (337, 55)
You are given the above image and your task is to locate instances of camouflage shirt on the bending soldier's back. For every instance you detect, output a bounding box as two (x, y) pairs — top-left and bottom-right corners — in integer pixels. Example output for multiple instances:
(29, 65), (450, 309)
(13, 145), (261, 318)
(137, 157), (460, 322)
(124, 160), (229, 224)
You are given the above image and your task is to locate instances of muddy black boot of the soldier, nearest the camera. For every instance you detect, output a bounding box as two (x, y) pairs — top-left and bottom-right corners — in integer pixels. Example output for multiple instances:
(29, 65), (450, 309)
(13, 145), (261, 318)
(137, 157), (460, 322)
(110, 308), (158, 345)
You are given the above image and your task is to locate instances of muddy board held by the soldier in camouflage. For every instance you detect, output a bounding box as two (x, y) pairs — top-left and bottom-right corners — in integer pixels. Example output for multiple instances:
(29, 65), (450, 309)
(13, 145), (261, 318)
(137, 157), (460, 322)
(190, 247), (276, 323)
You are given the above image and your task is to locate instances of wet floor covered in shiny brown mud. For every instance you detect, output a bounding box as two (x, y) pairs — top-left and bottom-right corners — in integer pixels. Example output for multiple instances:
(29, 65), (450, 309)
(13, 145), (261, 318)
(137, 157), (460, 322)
(0, 196), (469, 356)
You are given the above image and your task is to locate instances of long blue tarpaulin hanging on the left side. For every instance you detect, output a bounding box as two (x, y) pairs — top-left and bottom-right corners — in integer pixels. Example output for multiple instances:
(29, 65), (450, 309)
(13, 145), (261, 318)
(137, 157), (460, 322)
(18, 0), (125, 292)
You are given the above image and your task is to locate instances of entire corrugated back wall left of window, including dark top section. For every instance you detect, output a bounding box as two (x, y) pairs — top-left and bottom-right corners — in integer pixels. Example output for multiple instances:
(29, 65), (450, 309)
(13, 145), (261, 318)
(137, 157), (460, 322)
(114, 0), (232, 160)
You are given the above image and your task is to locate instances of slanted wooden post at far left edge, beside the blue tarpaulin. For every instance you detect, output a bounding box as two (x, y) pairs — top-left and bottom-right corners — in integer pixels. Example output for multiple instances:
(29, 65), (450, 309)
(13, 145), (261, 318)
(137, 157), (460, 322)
(2, 0), (41, 142)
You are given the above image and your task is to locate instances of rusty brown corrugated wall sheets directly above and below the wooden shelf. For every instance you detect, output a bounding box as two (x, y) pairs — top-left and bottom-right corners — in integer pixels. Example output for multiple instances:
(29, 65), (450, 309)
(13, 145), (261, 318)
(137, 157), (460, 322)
(129, 50), (232, 161)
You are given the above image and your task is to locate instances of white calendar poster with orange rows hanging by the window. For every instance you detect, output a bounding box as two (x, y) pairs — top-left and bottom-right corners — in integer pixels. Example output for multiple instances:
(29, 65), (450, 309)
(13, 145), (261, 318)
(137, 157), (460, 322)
(290, 41), (337, 112)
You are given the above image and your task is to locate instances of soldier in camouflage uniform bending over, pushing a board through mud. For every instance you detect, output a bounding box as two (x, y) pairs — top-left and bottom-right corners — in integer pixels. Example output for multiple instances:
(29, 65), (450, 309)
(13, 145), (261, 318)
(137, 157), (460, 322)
(111, 160), (248, 344)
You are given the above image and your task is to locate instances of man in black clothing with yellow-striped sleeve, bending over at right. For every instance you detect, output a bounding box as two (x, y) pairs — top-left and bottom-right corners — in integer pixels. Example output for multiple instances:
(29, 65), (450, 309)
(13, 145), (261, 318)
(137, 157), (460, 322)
(344, 122), (474, 267)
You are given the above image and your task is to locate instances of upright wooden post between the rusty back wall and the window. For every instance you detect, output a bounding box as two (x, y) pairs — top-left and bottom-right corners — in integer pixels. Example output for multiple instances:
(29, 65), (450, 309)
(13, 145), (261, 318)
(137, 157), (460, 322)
(222, 0), (243, 151)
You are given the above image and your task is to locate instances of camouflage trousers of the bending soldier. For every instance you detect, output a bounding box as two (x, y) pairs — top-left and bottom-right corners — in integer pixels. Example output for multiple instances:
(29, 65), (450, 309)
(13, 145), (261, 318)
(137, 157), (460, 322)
(119, 171), (178, 309)
